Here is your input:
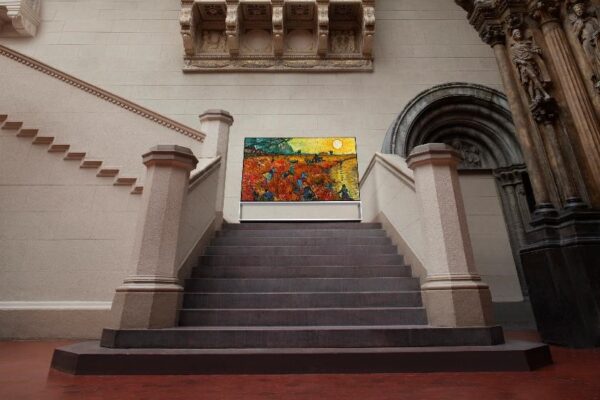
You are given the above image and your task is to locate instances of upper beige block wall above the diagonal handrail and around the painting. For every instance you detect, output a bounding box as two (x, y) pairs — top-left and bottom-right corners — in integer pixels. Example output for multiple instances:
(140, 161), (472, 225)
(0, 0), (500, 221)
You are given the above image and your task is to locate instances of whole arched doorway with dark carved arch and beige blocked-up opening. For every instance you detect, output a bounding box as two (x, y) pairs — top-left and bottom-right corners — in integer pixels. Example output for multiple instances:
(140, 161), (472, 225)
(382, 83), (534, 301)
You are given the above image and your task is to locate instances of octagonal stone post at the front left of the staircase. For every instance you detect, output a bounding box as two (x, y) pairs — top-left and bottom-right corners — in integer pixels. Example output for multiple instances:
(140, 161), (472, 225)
(111, 145), (198, 329)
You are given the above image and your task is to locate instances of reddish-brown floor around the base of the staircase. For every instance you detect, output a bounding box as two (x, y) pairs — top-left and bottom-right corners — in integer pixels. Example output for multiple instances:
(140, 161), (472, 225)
(0, 333), (600, 400)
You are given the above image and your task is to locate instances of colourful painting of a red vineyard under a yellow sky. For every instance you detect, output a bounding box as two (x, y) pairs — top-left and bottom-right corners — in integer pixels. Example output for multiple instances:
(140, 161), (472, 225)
(242, 137), (360, 202)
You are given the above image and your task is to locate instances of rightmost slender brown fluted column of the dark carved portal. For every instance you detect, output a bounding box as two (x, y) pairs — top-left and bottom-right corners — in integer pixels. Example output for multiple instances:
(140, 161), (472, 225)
(535, 8), (600, 207)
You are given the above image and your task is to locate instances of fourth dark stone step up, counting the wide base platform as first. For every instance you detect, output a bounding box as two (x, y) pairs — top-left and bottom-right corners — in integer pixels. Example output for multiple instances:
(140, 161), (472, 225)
(183, 291), (423, 309)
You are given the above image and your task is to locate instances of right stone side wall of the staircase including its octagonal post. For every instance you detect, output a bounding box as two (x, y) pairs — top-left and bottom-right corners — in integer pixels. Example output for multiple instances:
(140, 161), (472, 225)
(361, 143), (494, 327)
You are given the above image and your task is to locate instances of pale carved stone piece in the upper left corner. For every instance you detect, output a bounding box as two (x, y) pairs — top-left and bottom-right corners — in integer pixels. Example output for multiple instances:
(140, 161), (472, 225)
(0, 0), (41, 37)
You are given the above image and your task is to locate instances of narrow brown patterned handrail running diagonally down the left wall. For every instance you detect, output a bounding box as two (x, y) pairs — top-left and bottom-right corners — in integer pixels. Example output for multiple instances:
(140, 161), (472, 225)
(0, 44), (206, 142)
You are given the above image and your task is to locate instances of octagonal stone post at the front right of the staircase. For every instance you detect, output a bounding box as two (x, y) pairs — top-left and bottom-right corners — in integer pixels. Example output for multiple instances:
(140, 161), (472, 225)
(407, 143), (494, 327)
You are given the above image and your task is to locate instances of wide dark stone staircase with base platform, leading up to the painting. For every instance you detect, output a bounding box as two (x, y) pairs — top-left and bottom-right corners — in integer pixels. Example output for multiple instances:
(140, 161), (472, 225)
(52, 223), (552, 375)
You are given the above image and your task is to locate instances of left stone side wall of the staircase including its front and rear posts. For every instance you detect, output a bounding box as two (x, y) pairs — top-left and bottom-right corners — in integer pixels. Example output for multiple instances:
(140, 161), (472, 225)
(105, 110), (233, 329)
